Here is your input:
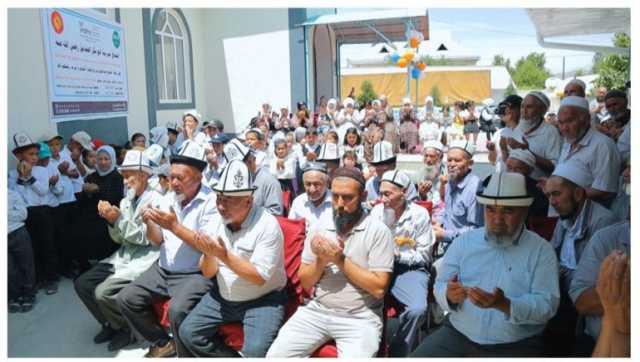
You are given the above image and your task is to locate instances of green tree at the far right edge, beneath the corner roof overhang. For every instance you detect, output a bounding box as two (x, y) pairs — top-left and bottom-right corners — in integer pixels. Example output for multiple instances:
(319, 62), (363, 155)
(593, 33), (631, 89)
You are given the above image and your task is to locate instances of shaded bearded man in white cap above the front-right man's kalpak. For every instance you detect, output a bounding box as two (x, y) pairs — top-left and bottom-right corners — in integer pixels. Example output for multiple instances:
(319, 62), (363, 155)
(505, 91), (562, 181)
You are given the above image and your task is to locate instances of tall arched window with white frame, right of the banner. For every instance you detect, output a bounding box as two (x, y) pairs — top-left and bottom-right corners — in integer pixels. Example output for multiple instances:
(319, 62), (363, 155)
(153, 9), (191, 104)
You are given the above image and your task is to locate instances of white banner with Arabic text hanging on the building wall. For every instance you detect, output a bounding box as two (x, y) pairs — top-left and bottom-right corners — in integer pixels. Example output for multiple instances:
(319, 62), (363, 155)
(41, 9), (128, 122)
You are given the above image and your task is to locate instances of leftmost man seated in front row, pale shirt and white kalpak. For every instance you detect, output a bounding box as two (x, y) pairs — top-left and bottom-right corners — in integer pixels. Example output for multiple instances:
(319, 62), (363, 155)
(73, 150), (161, 351)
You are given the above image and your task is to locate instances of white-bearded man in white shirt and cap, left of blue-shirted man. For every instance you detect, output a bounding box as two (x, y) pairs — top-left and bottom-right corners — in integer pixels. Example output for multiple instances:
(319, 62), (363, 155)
(415, 141), (447, 206)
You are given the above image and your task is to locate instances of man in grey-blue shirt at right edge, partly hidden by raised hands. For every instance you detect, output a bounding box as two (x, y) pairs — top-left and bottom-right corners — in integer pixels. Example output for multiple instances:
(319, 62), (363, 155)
(569, 220), (631, 355)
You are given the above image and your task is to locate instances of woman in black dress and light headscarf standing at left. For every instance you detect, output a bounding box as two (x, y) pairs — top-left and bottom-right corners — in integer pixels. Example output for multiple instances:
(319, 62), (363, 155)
(70, 145), (124, 272)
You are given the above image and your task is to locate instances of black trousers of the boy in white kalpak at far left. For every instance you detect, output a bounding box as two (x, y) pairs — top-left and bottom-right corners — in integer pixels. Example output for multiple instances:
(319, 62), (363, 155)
(26, 206), (58, 281)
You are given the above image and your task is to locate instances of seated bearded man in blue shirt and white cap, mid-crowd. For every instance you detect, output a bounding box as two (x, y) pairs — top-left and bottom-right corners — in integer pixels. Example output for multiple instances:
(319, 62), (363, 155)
(433, 141), (483, 254)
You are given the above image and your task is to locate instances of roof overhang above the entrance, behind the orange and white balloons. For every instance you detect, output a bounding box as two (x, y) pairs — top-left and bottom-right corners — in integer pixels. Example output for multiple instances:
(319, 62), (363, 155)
(299, 8), (429, 48)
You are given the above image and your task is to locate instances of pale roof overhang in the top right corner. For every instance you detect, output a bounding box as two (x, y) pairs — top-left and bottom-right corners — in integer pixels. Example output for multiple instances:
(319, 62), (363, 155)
(527, 8), (631, 55)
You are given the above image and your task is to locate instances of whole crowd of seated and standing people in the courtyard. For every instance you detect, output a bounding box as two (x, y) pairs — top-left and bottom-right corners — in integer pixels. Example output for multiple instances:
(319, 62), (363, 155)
(8, 80), (631, 357)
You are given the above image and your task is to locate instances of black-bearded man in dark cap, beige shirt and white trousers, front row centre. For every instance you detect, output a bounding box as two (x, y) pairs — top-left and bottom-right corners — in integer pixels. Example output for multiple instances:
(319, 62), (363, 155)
(267, 167), (393, 357)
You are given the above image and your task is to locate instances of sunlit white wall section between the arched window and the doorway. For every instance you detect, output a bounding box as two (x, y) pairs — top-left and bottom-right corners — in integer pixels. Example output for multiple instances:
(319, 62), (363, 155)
(204, 9), (292, 132)
